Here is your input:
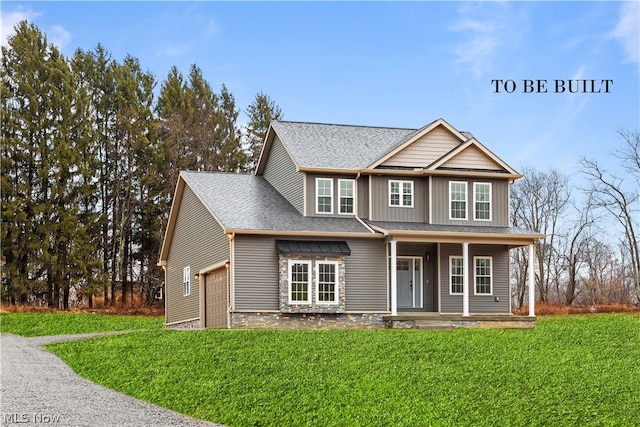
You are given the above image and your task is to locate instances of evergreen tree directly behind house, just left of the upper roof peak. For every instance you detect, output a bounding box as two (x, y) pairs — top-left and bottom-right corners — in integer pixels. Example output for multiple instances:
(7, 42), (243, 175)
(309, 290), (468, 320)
(246, 92), (283, 169)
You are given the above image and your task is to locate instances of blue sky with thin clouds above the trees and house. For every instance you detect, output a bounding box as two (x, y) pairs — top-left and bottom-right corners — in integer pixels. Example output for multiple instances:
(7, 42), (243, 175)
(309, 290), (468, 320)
(0, 1), (640, 180)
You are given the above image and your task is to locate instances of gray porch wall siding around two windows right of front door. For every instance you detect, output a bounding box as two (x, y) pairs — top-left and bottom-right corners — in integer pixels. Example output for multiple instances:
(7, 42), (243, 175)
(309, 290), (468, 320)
(439, 243), (511, 314)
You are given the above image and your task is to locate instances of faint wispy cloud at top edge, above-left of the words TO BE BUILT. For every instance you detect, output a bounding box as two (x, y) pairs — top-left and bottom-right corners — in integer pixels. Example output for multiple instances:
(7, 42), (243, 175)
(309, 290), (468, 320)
(449, 2), (528, 78)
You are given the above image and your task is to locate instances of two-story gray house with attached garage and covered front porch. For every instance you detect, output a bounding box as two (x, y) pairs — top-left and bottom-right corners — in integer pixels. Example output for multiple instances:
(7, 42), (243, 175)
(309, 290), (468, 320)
(160, 119), (543, 328)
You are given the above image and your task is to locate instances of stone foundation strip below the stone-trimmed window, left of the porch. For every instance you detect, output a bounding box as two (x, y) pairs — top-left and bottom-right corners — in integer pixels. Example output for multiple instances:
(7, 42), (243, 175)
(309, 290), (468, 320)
(231, 313), (384, 329)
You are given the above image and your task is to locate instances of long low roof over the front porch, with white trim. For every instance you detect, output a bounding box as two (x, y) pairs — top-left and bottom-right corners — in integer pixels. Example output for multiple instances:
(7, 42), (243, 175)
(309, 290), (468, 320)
(367, 221), (545, 247)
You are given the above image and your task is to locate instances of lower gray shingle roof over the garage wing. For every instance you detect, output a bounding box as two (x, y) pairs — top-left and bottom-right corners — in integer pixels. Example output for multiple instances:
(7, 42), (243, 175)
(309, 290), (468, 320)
(180, 172), (371, 234)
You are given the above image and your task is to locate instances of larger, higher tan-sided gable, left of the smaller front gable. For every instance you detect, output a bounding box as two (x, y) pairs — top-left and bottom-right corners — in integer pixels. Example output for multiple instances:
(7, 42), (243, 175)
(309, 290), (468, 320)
(380, 125), (462, 168)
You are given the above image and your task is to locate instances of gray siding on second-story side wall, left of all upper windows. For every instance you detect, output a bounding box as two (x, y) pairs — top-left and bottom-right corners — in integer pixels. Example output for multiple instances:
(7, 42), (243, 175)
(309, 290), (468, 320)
(262, 136), (304, 214)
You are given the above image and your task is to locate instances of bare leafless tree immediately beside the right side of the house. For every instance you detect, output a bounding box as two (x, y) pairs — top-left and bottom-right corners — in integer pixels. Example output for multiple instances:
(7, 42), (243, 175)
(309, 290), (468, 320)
(511, 168), (571, 303)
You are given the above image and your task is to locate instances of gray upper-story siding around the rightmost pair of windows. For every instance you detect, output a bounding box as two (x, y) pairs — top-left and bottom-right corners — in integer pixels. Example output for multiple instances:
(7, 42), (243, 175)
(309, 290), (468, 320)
(432, 177), (509, 227)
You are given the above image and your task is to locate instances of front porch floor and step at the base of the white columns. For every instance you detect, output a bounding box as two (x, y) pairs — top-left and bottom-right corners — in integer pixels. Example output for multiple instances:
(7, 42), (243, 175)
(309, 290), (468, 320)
(382, 312), (536, 330)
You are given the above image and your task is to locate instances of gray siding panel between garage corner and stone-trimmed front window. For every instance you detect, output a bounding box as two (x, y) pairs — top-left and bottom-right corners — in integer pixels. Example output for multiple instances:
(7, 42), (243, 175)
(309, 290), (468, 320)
(234, 235), (280, 310)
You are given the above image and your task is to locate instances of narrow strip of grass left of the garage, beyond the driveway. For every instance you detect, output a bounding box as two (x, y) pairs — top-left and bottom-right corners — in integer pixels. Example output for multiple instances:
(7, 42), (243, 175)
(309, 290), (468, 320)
(0, 312), (164, 337)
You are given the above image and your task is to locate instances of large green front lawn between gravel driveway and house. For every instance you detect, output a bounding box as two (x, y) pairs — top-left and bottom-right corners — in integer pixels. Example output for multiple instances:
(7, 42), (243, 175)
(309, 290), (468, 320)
(42, 314), (640, 426)
